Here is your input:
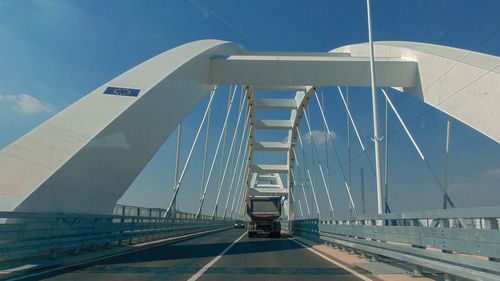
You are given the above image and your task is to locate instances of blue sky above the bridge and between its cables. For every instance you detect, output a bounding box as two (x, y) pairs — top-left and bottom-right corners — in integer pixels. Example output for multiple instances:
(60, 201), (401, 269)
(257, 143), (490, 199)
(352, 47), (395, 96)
(0, 0), (500, 217)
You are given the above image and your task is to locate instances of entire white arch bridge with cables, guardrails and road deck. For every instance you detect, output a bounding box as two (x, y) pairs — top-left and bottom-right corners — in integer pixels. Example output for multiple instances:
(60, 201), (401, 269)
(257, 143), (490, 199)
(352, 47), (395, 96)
(0, 30), (500, 280)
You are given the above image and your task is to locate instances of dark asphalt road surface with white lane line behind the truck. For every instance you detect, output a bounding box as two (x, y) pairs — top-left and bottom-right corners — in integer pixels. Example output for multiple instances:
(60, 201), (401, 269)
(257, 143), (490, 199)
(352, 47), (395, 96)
(34, 229), (360, 281)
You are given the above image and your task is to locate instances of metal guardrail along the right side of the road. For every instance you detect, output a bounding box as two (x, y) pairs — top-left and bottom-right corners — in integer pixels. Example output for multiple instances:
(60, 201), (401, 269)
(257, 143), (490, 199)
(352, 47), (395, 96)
(290, 206), (500, 281)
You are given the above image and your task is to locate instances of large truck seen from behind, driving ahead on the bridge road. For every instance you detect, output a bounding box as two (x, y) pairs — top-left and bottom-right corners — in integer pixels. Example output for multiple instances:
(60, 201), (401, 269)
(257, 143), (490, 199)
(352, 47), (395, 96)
(247, 196), (281, 238)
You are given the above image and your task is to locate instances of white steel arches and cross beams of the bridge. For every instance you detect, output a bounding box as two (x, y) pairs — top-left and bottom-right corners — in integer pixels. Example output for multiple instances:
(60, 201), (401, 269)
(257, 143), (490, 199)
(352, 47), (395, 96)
(0, 40), (500, 214)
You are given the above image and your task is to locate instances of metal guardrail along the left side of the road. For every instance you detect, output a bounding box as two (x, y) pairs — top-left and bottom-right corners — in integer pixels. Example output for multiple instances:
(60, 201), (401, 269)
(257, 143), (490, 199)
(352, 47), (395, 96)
(0, 206), (232, 261)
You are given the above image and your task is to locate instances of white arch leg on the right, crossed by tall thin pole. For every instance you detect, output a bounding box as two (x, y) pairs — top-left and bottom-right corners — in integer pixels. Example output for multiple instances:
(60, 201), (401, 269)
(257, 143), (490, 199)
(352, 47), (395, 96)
(332, 42), (500, 142)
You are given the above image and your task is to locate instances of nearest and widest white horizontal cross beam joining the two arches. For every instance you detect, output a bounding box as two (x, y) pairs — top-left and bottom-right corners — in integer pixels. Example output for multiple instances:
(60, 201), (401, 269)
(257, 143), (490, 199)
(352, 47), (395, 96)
(210, 55), (418, 88)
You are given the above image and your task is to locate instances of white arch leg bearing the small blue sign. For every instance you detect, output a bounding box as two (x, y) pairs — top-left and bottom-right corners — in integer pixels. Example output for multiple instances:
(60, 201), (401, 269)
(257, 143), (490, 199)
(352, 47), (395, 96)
(0, 40), (240, 213)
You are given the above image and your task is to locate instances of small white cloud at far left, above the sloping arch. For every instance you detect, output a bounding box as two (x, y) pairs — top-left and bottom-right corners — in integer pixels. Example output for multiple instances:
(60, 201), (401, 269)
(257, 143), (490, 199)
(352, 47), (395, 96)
(0, 94), (54, 114)
